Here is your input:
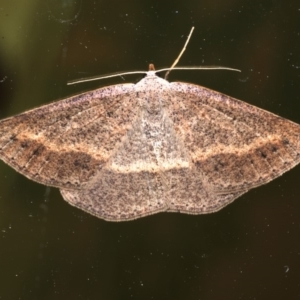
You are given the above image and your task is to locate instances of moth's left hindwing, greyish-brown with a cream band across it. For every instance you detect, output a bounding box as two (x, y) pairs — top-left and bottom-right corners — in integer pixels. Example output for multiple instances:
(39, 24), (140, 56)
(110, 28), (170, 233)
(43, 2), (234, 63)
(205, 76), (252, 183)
(61, 110), (171, 221)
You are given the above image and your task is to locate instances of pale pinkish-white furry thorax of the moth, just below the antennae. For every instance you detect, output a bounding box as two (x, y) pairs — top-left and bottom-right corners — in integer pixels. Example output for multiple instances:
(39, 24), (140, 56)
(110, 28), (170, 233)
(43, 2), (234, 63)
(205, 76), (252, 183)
(135, 71), (170, 114)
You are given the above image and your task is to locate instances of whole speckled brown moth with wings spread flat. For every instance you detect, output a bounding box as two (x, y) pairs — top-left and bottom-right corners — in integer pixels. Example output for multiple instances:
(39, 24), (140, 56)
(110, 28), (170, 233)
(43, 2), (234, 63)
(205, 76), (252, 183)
(0, 28), (300, 221)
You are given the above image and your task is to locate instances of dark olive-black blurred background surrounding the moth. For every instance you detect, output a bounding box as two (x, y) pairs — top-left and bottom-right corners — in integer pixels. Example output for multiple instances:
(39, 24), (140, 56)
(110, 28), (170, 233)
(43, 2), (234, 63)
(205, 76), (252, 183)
(0, 0), (300, 300)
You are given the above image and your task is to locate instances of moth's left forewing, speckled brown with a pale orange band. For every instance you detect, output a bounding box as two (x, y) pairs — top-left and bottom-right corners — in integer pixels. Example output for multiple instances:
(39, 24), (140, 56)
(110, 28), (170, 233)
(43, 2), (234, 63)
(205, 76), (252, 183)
(0, 84), (138, 189)
